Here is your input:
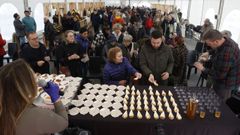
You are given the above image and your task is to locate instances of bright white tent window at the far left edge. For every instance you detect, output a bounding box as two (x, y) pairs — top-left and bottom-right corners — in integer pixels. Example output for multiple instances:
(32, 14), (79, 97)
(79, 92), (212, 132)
(0, 3), (18, 40)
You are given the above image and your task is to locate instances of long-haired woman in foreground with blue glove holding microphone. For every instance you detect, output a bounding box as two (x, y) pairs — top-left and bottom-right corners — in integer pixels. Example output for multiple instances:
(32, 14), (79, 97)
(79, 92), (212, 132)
(0, 59), (68, 135)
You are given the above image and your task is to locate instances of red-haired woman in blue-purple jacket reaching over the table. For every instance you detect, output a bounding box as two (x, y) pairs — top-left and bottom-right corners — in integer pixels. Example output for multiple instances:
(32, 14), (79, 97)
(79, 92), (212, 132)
(103, 47), (142, 85)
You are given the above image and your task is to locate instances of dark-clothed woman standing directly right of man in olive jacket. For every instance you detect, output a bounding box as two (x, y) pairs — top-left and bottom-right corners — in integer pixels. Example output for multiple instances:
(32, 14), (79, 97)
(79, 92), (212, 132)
(172, 36), (188, 84)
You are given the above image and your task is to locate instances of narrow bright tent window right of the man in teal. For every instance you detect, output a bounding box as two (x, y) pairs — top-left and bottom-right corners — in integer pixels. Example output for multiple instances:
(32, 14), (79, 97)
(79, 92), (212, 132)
(34, 3), (44, 31)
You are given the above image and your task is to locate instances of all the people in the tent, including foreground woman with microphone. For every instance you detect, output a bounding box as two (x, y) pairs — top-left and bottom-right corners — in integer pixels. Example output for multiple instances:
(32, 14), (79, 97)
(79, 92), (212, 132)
(0, 4), (240, 134)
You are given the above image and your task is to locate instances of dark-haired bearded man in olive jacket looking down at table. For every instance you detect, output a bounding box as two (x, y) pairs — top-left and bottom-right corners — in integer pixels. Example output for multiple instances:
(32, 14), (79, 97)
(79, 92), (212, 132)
(140, 30), (174, 85)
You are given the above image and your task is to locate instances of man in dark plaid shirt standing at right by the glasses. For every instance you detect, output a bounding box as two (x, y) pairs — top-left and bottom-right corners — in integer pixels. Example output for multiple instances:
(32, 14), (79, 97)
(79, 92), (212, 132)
(195, 30), (240, 100)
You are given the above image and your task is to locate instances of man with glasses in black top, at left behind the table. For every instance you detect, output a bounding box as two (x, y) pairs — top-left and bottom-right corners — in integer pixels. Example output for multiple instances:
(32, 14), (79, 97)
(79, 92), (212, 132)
(20, 32), (50, 74)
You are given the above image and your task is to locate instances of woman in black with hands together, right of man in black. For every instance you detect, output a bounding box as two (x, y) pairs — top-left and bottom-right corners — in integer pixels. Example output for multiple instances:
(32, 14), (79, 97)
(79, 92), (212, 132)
(57, 30), (83, 77)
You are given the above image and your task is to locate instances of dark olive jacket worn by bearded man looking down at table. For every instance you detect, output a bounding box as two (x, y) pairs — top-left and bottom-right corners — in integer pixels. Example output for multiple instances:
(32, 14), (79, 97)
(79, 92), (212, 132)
(140, 41), (174, 85)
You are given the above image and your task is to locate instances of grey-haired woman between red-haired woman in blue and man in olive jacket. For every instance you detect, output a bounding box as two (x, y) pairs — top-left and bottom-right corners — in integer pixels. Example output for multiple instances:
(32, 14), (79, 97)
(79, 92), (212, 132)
(120, 34), (139, 67)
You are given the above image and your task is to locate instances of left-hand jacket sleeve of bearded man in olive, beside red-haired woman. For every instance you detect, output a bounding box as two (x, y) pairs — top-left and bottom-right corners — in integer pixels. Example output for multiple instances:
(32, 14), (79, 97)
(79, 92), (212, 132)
(139, 46), (152, 77)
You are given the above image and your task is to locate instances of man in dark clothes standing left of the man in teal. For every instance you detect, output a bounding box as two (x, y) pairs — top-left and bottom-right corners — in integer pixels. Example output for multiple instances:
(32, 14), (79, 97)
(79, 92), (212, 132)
(13, 13), (26, 47)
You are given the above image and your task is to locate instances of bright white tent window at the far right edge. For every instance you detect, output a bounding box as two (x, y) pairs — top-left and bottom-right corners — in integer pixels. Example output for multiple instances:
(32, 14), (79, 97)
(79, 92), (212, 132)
(220, 10), (240, 42)
